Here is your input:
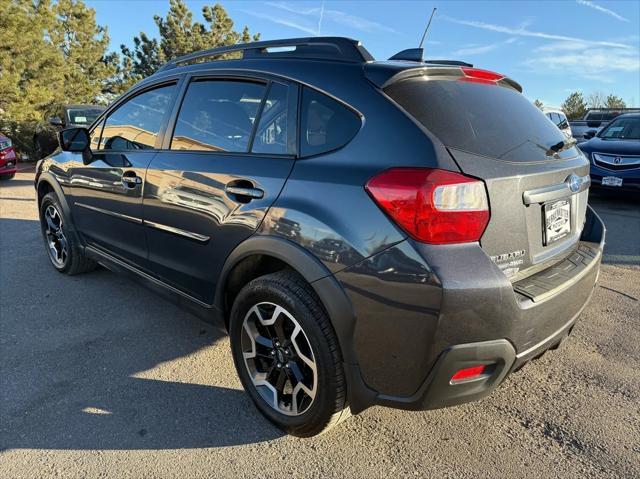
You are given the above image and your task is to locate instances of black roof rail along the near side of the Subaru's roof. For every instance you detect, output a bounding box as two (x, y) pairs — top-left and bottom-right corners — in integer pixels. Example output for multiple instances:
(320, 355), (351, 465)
(158, 37), (374, 71)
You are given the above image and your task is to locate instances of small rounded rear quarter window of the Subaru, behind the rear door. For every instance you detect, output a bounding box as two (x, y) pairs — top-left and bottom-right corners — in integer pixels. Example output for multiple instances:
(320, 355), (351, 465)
(300, 88), (361, 156)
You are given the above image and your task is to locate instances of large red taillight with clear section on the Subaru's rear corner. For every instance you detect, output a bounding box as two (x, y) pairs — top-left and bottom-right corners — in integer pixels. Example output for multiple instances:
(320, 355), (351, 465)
(366, 168), (489, 244)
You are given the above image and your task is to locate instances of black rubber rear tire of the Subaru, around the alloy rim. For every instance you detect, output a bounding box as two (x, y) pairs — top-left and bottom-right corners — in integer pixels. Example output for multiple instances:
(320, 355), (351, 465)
(229, 270), (350, 437)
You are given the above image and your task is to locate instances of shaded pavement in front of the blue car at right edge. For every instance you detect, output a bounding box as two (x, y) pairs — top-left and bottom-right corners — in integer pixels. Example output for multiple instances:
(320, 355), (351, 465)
(589, 189), (640, 266)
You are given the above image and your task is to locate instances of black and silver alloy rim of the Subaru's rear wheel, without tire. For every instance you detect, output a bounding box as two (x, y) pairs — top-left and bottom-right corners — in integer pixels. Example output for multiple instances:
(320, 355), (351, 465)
(241, 302), (318, 416)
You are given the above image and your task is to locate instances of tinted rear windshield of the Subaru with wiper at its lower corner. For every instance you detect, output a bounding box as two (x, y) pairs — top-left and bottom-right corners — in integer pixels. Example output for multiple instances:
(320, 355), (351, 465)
(385, 78), (566, 162)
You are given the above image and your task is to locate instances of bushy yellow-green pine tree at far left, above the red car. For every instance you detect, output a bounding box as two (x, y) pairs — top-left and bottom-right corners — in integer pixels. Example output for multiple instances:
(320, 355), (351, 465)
(0, 0), (119, 152)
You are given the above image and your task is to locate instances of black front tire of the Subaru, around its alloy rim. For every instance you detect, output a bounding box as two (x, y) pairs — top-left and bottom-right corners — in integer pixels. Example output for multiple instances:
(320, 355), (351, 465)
(40, 192), (96, 276)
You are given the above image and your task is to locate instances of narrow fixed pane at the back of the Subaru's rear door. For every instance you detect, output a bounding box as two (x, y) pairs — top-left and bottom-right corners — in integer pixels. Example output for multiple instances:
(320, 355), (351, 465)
(251, 83), (289, 155)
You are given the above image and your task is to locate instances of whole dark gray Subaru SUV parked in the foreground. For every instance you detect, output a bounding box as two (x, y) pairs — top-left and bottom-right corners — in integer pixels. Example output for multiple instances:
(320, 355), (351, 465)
(36, 37), (605, 436)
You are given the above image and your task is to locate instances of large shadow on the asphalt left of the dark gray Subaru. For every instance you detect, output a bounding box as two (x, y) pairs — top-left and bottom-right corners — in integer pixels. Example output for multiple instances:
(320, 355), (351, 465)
(0, 219), (282, 450)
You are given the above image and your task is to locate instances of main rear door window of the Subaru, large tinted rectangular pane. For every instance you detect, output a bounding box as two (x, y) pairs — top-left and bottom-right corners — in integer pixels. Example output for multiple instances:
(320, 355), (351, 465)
(171, 80), (265, 152)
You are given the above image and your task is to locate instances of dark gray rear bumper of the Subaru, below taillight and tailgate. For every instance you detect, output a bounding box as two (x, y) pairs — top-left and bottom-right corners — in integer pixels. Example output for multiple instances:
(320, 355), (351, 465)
(337, 207), (605, 409)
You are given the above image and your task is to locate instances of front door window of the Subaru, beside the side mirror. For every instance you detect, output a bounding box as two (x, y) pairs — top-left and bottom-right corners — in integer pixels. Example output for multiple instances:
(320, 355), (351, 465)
(100, 85), (176, 150)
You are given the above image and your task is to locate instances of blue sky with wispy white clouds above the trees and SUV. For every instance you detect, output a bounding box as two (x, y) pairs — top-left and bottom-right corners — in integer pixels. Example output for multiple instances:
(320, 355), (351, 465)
(86, 0), (640, 106)
